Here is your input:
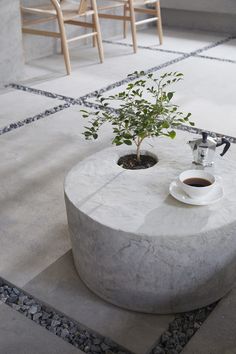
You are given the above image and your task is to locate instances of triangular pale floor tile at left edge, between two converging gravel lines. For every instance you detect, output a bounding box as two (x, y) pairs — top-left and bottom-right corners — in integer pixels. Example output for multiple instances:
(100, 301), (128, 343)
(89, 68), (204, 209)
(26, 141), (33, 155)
(0, 90), (65, 128)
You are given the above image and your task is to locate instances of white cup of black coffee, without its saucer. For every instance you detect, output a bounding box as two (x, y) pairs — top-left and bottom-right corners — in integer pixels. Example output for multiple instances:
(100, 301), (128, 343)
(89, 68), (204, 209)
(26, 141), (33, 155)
(178, 170), (216, 199)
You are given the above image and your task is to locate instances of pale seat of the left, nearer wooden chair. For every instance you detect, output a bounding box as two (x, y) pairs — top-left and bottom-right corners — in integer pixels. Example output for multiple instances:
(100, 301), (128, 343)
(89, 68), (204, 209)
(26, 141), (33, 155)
(21, 0), (94, 21)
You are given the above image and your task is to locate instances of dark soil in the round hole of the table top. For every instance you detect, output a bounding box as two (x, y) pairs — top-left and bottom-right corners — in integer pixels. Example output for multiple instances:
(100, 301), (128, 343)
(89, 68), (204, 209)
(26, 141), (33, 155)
(117, 154), (157, 170)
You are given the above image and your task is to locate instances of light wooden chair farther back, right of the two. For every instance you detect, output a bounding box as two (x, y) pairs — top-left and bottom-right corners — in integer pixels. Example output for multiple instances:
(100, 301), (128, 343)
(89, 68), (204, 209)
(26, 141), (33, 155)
(98, 0), (163, 53)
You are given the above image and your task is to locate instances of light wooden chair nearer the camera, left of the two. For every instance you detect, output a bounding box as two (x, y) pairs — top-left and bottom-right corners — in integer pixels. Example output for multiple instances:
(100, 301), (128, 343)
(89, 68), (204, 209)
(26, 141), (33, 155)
(21, 0), (104, 75)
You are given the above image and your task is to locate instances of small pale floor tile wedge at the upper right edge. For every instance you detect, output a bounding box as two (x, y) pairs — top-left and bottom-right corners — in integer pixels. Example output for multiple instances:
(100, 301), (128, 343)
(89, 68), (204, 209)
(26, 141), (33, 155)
(201, 39), (236, 61)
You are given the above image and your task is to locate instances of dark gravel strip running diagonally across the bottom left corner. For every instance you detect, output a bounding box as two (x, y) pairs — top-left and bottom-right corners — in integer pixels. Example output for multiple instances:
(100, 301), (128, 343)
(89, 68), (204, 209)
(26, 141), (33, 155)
(0, 278), (132, 354)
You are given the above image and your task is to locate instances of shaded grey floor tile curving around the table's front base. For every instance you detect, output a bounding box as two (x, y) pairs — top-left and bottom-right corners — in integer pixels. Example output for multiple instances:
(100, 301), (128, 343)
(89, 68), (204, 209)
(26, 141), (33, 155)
(25, 252), (173, 354)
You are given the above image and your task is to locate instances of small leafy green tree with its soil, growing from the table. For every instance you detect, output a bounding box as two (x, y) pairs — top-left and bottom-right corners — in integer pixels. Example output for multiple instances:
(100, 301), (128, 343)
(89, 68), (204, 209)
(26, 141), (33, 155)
(81, 71), (194, 169)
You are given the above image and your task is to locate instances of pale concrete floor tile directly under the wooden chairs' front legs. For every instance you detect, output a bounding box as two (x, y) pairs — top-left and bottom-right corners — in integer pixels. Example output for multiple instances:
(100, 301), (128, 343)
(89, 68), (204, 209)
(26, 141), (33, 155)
(27, 44), (177, 97)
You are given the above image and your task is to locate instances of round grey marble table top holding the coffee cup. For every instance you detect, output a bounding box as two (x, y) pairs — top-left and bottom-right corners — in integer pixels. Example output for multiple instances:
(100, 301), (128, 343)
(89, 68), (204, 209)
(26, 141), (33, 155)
(65, 131), (236, 238)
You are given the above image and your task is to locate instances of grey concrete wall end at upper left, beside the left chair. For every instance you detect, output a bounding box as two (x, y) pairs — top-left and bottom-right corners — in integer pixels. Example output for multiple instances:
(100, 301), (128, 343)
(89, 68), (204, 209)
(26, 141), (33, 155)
(0, 0), (23, 86)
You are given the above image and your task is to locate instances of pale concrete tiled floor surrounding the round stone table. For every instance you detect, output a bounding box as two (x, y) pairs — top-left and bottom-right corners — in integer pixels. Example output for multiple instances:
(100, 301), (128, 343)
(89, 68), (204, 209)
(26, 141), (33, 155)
(0, 28), (236, 354)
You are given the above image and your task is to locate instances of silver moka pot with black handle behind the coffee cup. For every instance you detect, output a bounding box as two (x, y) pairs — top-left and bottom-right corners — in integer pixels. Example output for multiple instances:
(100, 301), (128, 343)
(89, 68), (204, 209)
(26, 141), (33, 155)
(188, 132), (230, 167)
